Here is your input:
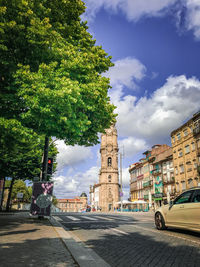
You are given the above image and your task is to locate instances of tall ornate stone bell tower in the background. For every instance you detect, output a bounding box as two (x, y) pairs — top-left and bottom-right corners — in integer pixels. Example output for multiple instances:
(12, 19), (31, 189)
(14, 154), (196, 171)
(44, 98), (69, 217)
(99, 126), (120, 212)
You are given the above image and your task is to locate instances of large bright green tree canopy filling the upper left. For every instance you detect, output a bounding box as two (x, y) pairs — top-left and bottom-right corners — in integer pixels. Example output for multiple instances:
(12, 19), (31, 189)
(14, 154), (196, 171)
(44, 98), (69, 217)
(0, 0), (115, 145)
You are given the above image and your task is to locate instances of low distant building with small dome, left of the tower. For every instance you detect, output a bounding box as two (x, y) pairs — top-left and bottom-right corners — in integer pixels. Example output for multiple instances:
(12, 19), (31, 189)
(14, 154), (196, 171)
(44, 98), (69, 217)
(56, 193), (88, 212)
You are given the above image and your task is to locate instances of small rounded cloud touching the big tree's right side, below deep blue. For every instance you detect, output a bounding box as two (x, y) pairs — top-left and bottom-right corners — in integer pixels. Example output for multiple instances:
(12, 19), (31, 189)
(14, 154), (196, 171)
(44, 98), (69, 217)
(105, 57), (146, 89)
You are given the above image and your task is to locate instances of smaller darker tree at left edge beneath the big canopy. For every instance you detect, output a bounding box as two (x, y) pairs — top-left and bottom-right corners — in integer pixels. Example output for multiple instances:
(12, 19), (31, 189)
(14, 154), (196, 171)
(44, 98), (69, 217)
(0, 118), (58, 211)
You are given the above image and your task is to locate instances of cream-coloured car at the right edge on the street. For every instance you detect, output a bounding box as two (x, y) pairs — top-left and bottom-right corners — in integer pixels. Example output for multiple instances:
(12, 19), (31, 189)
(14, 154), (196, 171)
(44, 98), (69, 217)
(155, 187), (200, 232)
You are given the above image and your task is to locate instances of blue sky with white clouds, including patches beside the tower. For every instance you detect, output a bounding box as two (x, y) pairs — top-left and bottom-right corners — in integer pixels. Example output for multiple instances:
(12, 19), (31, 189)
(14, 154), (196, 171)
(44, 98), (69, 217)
(54, 0), (200, 199)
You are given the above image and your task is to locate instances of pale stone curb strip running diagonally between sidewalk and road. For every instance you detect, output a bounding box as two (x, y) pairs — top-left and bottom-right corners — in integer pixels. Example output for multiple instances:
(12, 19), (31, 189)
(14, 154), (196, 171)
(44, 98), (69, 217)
(49, 217), (110, 267)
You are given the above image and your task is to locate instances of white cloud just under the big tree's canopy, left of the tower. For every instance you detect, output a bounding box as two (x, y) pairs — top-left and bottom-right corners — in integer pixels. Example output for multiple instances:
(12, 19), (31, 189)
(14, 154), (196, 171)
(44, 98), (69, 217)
(56, 140), (92, 170)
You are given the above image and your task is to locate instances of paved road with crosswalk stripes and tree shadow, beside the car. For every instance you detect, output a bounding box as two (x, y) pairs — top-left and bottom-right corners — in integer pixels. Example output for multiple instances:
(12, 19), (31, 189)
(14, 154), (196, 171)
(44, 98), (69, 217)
(54, 213), (200, 267)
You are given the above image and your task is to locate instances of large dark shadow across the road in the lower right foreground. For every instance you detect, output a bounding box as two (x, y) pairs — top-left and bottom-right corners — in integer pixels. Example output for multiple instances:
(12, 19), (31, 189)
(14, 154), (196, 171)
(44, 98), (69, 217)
(82, 229), (200, 267)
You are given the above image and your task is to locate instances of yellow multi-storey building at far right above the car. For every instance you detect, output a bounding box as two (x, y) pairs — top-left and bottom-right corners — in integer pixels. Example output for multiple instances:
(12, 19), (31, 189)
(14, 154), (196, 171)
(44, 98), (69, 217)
(171, 112), (200, 194)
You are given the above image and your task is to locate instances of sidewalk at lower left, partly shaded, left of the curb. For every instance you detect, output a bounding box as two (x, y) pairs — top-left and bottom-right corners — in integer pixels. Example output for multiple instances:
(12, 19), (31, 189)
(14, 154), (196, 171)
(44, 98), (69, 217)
(0, 213), (77, 267)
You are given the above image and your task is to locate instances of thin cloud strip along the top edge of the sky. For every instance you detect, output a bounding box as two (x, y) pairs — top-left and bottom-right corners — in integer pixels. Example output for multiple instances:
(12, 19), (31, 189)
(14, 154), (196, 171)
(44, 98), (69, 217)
(83, 0), (200, 39)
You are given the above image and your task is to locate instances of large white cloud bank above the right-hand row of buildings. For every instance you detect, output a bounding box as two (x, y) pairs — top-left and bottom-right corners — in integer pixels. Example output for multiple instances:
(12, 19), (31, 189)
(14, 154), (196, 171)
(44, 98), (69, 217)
(111, 75), (200, 141)
